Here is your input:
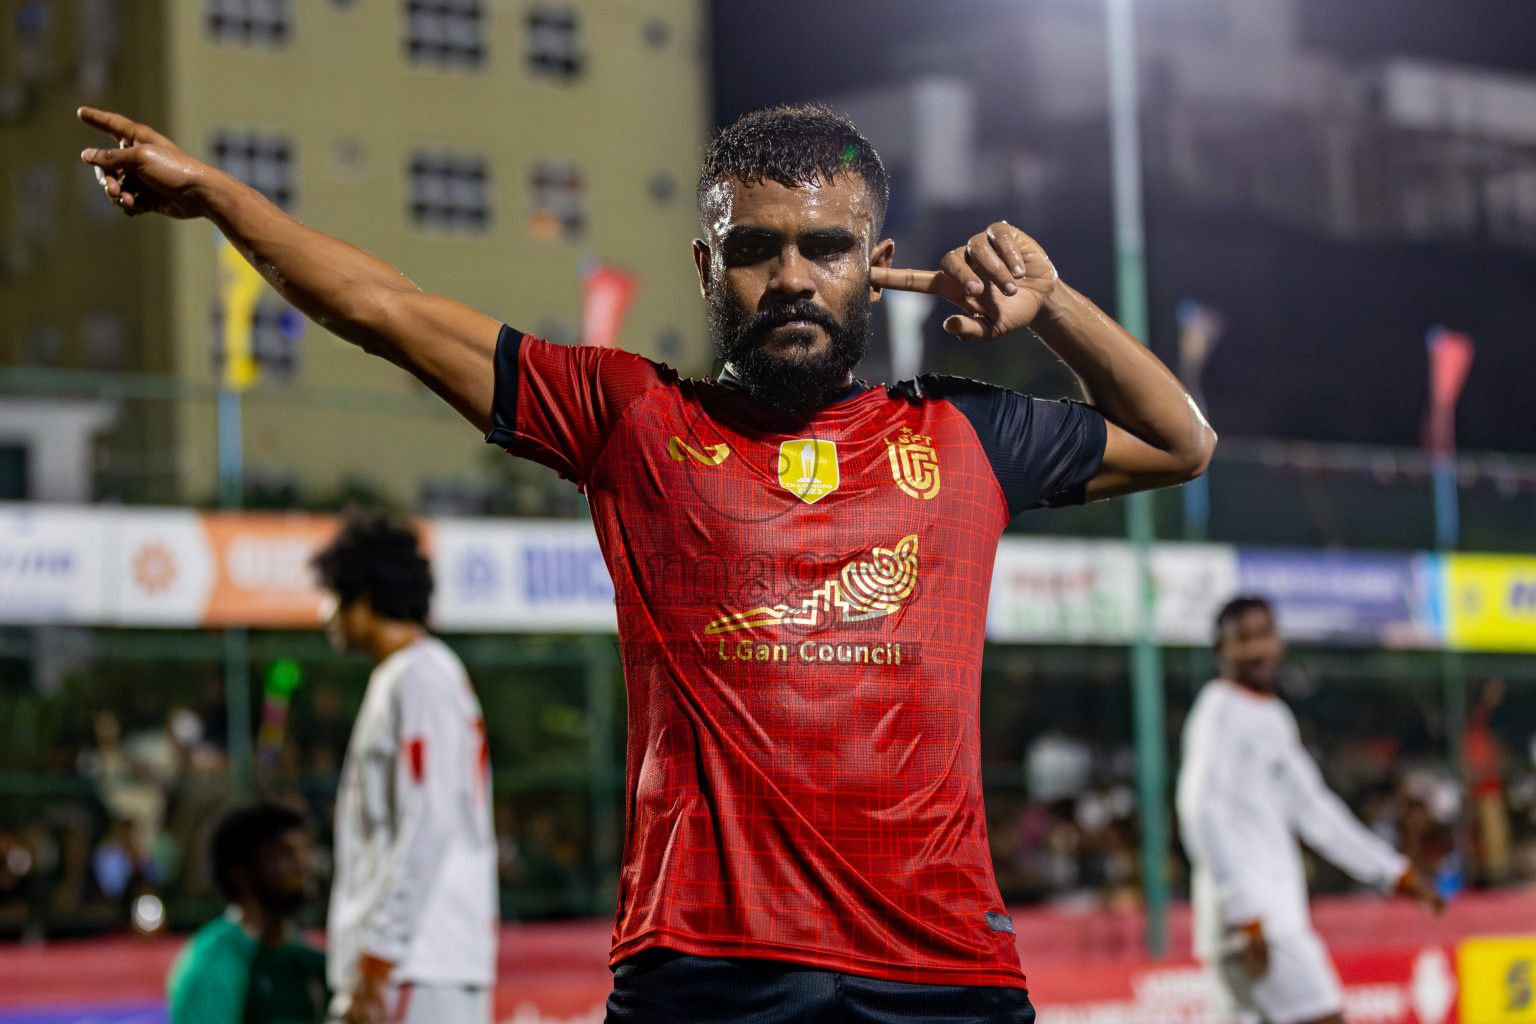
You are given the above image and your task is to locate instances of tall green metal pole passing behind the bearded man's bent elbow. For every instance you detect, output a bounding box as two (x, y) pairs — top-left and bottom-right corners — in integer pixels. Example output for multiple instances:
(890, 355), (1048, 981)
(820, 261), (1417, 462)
(1104, 0), (1169, 956)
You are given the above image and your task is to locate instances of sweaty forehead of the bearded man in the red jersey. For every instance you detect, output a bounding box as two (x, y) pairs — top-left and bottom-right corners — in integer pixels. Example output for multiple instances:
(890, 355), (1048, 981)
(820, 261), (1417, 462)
(703, 175), (874, 246)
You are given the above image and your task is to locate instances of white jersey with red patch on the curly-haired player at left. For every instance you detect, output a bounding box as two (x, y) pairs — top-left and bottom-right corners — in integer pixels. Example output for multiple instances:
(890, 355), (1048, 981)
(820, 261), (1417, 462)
(327, 637), (498, 1013)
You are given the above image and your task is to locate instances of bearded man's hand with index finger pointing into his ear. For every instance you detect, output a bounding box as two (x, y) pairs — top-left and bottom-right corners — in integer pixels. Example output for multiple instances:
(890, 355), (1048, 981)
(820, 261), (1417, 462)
(869, 221), (1057, 339)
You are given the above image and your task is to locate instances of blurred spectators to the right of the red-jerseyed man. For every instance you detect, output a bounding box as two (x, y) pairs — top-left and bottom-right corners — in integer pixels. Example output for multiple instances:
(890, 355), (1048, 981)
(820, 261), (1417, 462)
(988, 679), (1536, 909)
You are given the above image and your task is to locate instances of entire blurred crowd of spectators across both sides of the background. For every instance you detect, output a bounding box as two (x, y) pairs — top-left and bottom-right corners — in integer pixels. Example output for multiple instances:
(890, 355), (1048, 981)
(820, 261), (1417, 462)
(0, 669), (1536, 938)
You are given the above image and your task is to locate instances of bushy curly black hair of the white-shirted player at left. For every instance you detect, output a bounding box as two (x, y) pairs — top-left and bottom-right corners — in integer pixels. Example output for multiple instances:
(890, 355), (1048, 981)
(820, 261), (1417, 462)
(312, 510), (432, 623)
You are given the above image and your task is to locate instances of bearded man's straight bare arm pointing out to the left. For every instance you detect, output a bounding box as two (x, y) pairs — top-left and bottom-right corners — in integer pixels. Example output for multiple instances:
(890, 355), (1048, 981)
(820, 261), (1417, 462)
(80, 107), (501, 433)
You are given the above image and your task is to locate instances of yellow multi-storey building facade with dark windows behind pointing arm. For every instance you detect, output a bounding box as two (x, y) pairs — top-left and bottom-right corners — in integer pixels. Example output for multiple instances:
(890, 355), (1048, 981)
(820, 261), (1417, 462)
(0, 0), (710, 508)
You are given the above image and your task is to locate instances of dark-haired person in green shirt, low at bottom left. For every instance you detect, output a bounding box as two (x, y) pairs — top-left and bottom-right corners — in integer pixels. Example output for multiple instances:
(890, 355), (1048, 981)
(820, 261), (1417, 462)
(166, 804), (329, 1024)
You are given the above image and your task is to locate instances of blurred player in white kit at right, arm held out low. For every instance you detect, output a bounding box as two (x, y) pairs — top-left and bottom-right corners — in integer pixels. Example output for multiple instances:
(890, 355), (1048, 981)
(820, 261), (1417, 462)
(1178, 597), (1444, 1024)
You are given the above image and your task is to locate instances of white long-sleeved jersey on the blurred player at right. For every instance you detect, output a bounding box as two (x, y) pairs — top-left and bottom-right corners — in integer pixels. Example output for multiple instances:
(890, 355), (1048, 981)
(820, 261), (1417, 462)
(1178, 679), (1409, 960)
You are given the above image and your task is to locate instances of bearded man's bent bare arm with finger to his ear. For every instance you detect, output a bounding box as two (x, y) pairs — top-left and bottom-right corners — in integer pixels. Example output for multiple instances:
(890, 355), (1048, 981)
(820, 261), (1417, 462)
(869, 221), (1217, 497)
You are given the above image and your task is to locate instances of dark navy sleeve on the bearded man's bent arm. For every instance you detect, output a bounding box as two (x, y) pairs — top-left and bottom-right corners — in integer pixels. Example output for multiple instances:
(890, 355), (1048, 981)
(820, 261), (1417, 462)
(917, 373), (1107, 516)
